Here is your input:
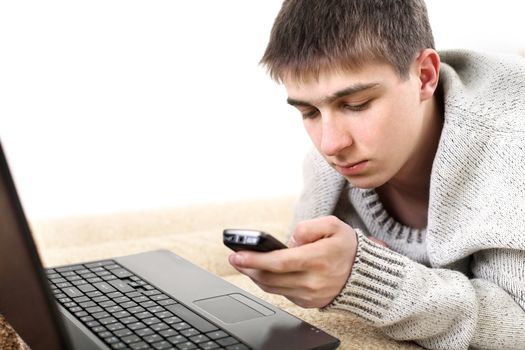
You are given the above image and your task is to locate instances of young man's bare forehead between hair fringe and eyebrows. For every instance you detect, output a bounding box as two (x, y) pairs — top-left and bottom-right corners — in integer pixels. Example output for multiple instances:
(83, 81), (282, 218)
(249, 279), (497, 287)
(282, 63), (399, 100)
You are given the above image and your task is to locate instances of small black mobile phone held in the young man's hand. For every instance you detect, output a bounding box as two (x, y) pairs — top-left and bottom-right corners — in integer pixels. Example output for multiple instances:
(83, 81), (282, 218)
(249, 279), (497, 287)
(222, 228), (288, 252)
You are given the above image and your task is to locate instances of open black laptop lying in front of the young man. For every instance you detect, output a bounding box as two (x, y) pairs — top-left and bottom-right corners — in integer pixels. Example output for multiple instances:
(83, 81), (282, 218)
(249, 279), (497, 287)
(0, 145), (339, 350)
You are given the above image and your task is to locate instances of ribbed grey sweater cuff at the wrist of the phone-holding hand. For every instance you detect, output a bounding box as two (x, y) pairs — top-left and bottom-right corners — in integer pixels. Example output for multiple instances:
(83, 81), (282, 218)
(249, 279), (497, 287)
(322, 230), (410, 325)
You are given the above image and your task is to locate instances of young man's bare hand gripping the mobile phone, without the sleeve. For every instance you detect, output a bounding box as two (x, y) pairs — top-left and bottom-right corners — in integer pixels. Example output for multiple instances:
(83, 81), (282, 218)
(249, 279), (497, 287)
(229, 216), (357, 308)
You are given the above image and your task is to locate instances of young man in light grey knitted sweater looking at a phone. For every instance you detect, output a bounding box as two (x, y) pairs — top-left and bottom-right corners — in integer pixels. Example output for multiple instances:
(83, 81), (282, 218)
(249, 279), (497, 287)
(230, 0), (525, 350)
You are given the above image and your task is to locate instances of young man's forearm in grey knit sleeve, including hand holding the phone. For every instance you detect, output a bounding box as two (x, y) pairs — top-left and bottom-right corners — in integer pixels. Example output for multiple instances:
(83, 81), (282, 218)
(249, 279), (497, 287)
(230, 217), (525, 350)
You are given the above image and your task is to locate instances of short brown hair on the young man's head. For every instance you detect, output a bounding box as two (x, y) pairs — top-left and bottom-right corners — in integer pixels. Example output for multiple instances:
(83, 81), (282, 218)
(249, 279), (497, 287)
(260, 0), (434, 82)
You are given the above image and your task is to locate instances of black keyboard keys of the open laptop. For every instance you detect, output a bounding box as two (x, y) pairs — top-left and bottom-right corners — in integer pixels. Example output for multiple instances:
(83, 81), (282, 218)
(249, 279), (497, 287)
(46, 260), (249, 350)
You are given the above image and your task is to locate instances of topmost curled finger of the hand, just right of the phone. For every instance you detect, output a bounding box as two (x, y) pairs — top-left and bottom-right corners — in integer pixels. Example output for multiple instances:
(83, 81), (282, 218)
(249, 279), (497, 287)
(288, 215), (346, 247)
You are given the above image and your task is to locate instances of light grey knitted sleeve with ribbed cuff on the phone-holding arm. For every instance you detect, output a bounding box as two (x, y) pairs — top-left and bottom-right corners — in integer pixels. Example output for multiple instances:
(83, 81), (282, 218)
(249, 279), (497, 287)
(336, 230), (525, 349)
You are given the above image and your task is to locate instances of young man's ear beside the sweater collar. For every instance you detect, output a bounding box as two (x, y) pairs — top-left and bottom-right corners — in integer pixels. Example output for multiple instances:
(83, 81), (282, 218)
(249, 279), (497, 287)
(415, 49), (441, 101)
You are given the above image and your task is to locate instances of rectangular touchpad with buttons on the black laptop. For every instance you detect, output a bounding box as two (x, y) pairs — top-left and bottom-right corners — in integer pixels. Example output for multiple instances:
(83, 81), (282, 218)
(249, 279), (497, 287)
(193, 294), (275, 323)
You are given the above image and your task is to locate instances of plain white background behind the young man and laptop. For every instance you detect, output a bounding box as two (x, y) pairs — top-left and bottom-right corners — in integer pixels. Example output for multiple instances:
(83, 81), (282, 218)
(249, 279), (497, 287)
(0, 0), (525, 219)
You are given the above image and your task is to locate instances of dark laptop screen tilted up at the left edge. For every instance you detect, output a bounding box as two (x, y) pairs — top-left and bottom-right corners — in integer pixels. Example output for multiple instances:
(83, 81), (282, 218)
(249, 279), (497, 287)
(0, 144), (67, 350)
